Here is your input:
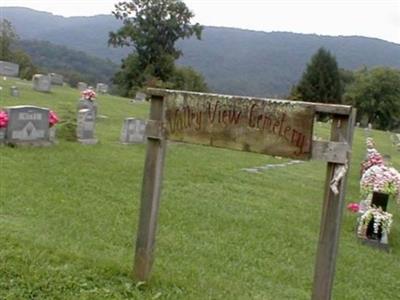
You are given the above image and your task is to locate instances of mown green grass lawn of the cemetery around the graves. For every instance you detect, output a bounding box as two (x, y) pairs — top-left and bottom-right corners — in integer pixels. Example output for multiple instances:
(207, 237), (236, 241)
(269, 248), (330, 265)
(0, 79), (400, 299)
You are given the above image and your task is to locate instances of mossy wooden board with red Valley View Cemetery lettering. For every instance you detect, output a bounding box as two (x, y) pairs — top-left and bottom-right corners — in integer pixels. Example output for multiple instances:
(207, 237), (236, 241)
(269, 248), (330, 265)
(164, 93), (315, 160)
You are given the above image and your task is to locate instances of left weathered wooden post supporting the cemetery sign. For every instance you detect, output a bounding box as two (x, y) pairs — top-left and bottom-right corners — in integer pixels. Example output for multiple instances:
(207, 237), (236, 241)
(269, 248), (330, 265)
(133, 96), (166, 281)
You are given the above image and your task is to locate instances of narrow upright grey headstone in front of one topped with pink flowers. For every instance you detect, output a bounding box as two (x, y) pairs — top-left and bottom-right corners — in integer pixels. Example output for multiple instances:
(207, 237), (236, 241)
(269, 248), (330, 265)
(76, 108), (97, 144)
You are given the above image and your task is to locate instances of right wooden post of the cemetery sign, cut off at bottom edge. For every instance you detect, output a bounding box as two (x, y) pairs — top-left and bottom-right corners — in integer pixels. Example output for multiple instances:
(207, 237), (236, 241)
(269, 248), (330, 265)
(312, 109), (355, 300)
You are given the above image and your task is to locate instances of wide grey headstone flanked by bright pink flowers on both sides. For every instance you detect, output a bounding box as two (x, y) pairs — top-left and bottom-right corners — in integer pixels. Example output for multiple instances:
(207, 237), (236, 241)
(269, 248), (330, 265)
(5, 106), (54, 146)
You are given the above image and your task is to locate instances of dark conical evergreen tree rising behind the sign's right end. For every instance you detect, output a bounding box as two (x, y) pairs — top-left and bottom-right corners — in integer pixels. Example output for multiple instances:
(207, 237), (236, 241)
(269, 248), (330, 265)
(291, 48), (343, 103)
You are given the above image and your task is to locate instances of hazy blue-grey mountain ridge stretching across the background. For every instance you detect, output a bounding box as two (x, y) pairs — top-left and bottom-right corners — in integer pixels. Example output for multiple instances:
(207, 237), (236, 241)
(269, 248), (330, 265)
(0, 7), (400, 96)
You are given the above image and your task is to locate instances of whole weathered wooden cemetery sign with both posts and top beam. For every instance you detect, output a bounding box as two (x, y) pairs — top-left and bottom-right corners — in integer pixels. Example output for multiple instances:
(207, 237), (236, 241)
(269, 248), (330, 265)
(134, 89), (356, 300)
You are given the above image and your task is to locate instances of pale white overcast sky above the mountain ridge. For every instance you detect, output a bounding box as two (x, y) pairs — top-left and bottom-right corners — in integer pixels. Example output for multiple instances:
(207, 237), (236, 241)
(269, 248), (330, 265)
(0, 0), (400, 44)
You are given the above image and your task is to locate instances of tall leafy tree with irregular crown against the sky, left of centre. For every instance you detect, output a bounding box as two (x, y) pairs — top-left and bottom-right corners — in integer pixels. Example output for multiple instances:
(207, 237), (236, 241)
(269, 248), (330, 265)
(108, 0), (203, 94)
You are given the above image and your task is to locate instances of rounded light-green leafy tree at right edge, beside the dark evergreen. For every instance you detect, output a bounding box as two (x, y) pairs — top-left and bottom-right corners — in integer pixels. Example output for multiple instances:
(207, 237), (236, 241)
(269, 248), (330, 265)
(344, 67), (400, 130)
